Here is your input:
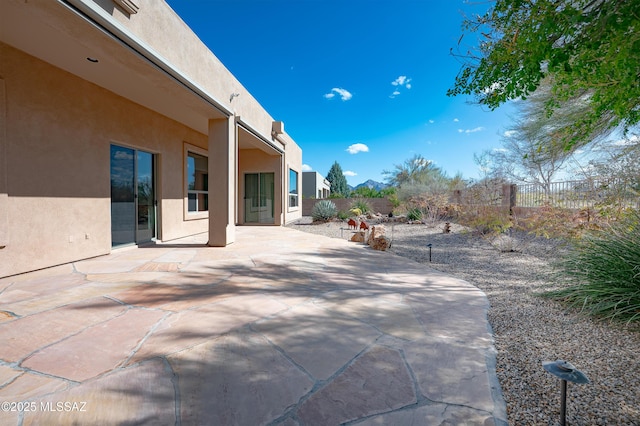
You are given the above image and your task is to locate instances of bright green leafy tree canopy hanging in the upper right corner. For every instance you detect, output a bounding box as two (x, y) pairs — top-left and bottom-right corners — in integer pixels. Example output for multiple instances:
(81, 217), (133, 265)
(447, 0), (640, 148)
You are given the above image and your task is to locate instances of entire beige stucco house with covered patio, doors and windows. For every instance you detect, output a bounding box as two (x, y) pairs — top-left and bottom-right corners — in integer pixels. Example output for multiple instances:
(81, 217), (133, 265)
(0, 0), (302, 277)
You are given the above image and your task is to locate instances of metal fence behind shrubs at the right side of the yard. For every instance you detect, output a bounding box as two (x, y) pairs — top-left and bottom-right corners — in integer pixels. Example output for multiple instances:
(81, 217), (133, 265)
(515, 179), (640, 209)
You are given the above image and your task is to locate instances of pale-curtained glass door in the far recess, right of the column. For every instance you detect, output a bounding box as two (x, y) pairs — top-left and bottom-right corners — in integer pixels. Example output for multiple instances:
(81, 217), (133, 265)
(244, 173), (275, 223)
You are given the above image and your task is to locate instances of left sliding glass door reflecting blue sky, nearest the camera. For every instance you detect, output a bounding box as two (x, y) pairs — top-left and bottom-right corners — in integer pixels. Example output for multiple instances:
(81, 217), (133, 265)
(111, 145), (156, 247)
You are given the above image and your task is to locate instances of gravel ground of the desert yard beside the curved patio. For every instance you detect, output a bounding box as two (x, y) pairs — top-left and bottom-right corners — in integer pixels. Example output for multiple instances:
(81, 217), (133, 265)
(289, 218), (640, 425)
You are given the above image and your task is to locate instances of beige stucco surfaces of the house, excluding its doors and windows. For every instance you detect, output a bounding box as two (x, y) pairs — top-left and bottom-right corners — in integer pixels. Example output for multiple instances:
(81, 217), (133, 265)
(0, 0), (302, 277)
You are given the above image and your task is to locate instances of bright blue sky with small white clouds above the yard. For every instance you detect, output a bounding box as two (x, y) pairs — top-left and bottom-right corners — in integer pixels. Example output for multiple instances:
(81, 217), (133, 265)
(167, 0), (513, 186)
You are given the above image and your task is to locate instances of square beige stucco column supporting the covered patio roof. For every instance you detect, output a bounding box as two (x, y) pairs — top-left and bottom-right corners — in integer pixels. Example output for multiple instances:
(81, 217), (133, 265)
(208, 116), (237, 247)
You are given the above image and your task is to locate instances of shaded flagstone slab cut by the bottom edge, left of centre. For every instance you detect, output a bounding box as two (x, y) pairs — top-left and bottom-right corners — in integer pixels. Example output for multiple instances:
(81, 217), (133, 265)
(168, 331), (314, 425)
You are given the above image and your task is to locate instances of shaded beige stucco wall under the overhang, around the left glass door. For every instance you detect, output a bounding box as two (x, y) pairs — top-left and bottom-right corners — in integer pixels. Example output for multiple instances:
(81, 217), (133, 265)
(0, 43), (207, 276)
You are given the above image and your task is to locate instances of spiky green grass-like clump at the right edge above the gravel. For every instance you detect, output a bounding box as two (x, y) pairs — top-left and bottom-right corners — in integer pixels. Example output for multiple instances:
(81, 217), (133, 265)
(546, 212), (640, 322)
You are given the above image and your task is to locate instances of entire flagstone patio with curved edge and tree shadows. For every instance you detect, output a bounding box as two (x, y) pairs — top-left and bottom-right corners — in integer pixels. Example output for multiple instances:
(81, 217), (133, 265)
(0, 227), (506, 426)
